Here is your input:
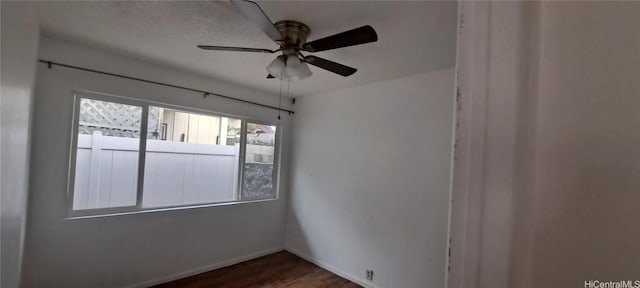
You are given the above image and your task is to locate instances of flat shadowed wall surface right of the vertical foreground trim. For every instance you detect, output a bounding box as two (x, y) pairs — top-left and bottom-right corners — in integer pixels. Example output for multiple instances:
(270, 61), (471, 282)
(531, 2), (640, 287)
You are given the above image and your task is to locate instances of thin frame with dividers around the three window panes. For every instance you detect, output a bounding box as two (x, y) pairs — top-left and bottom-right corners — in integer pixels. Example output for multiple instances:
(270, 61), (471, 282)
(65, 90), (281, 219)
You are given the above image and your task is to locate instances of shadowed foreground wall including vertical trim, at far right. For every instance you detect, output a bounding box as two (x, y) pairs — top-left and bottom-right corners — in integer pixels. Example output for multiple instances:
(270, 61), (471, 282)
(449, 1), (640, 288)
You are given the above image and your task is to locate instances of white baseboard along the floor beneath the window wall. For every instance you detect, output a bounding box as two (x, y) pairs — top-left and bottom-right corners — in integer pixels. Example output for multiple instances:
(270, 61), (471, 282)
(123, 247), (284, 288)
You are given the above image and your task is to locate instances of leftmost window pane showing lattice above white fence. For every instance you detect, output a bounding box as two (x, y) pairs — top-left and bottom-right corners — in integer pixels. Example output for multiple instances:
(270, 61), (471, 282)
(73, 99), (142, 210)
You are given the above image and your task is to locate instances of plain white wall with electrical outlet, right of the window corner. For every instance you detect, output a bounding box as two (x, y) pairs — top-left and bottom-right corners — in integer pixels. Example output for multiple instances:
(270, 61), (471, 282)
(286, 69), (454, 288)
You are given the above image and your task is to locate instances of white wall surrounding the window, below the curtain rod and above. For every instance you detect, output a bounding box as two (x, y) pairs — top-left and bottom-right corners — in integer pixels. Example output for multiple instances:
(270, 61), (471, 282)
(23, 37), (289, 287)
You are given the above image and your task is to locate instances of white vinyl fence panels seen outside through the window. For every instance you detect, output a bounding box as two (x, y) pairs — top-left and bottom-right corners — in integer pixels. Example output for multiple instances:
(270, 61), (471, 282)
(73, 131), (240, 210)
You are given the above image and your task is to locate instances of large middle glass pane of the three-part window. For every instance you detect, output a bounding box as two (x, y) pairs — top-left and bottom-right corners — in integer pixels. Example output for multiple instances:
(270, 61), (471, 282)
(142, 106), (241, 208)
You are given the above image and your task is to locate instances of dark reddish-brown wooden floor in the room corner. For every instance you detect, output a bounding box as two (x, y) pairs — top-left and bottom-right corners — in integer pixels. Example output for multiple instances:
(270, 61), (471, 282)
(155, 251), (361, 288)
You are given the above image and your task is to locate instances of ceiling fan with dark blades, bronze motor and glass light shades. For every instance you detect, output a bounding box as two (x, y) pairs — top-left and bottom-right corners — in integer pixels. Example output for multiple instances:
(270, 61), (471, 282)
(198, 0), (378, 81)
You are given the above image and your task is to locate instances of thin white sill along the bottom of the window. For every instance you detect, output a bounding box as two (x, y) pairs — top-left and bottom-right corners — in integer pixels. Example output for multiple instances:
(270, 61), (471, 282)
(64, 197), (279, 220)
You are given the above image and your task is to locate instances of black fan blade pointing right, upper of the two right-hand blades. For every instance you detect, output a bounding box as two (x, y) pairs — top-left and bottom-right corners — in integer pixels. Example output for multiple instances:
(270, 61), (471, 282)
(304, 25), (378, 52)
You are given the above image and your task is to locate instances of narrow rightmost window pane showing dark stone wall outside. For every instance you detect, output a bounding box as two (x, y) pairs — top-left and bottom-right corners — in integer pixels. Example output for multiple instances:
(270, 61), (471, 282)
(242, 123), (276, 200)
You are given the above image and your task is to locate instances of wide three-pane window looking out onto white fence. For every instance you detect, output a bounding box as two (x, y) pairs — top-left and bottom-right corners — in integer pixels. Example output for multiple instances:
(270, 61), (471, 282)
(69, 93), (278, 216)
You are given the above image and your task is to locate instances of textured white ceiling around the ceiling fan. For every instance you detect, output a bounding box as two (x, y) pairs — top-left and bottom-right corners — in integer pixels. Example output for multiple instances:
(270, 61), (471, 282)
(36, 1), (457, 96)
